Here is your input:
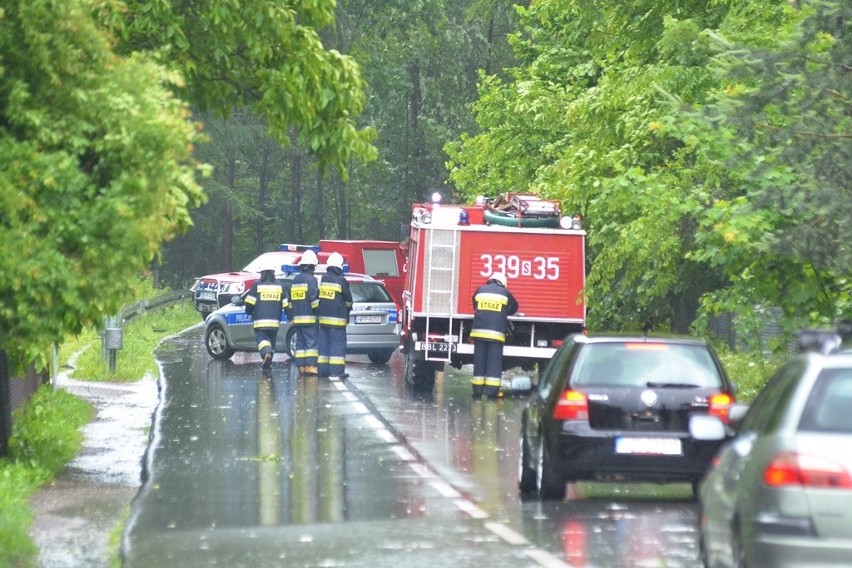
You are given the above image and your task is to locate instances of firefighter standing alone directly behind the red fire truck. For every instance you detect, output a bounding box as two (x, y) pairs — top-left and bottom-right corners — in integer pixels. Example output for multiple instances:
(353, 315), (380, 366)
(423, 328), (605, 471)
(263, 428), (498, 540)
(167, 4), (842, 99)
(470, 272), (518, 398)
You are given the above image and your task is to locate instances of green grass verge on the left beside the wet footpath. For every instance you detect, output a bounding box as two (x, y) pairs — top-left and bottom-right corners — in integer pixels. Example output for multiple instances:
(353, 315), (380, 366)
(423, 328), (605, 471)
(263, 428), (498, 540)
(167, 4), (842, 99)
(0, 289), (199, 568)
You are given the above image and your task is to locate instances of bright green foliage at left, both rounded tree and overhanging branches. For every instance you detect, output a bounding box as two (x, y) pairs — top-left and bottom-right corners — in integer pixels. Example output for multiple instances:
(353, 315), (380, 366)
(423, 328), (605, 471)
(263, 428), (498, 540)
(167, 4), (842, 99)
(0, 0), (374, 368)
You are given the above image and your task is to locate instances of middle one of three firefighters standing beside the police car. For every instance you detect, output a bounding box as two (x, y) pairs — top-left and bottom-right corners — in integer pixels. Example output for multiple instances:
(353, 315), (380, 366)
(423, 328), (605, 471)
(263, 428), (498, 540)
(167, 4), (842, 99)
(288, 250), (319, 375)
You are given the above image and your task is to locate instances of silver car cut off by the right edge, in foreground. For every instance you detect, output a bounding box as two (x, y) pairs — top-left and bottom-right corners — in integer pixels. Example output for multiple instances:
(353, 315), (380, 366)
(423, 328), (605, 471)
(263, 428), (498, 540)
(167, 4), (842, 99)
(699, 328), (852, 568)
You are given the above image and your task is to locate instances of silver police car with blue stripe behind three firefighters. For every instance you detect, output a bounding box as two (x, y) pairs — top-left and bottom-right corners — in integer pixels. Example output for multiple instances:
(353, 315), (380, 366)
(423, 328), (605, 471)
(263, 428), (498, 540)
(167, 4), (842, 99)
(204, 274), (400, 365)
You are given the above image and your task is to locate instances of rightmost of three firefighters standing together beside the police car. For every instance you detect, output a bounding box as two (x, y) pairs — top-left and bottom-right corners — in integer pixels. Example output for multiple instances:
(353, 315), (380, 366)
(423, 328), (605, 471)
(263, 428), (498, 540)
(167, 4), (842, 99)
(317, 252), (352, 380)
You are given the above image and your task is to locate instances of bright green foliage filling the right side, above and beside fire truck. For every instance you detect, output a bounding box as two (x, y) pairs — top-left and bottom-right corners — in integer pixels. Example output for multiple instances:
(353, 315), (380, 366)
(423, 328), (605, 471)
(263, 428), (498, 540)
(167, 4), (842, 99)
(447, 0), (852, 340)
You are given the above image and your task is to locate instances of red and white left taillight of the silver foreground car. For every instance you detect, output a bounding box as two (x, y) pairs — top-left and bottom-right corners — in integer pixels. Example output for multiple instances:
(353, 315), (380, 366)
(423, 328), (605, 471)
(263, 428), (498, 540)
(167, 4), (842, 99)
(763, 452), (852, 489)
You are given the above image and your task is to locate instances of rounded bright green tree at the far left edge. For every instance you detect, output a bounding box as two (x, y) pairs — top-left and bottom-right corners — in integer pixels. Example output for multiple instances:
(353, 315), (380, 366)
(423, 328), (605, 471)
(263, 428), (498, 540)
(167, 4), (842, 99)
(0, 0), (202, 363)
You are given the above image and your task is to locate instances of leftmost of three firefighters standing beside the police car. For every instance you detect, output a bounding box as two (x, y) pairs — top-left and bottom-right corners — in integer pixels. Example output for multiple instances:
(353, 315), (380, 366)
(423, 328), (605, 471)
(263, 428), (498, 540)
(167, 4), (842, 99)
(245, 266), (287, 373)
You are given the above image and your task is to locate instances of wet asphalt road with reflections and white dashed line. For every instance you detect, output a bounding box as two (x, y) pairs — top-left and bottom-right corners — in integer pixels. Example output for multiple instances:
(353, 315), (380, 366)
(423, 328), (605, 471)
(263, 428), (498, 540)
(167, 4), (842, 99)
(122, 327), (700, 568)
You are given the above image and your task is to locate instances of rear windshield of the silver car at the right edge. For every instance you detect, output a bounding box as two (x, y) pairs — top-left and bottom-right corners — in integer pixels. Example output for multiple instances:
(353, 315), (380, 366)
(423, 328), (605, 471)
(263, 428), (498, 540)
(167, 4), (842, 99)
(799, 369), (852, 434)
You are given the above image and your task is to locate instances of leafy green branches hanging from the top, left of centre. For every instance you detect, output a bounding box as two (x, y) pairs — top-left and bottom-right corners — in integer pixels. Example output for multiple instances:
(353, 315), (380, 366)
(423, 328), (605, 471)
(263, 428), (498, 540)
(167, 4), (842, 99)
(105, 0), (375, 175)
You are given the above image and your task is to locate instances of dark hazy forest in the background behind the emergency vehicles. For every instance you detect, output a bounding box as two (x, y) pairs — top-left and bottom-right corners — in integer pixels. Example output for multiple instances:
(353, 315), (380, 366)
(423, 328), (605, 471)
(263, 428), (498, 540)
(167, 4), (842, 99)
(162, 0), (516, 286)
